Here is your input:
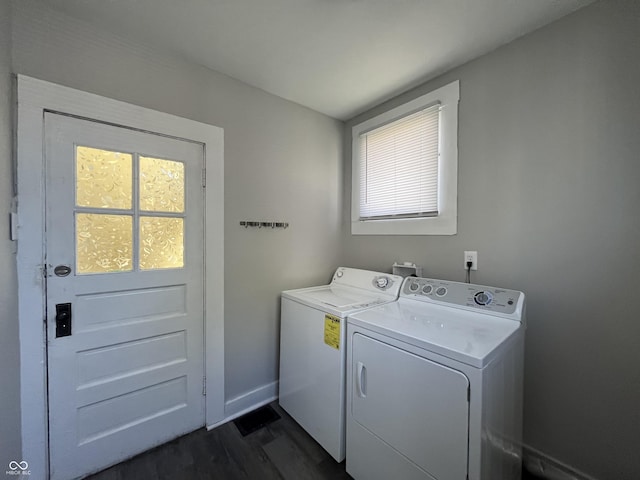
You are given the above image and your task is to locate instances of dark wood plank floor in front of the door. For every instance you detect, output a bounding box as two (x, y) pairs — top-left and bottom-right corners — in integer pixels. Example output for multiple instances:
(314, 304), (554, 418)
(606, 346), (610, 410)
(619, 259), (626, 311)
(88, 402), (537, 480)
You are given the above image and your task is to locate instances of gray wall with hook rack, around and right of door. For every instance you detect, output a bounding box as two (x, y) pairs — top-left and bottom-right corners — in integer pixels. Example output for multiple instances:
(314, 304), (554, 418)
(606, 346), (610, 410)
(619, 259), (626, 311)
(7, 0), (343, 412)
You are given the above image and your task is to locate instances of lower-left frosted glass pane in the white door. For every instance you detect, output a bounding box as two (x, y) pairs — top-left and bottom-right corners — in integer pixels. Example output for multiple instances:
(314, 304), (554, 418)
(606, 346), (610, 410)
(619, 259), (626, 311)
(76, 213), (133, 273)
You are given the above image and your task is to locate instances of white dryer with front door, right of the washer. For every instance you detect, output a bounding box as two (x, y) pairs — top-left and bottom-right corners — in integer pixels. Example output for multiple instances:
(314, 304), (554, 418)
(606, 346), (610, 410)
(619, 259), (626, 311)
(347, 277), (525, 480)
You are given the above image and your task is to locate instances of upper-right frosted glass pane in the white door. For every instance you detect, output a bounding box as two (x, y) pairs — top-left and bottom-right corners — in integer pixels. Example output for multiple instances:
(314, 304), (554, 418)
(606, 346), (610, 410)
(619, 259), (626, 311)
(140, 157), (184, 212)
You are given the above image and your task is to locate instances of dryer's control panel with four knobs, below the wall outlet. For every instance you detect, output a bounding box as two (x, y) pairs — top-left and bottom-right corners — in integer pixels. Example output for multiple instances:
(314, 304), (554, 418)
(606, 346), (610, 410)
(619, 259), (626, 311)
(400, 277), (524, 315)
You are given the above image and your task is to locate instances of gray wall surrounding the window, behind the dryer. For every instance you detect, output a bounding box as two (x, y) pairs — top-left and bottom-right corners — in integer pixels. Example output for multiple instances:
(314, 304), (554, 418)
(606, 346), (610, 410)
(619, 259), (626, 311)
(343, 0), (640, 480)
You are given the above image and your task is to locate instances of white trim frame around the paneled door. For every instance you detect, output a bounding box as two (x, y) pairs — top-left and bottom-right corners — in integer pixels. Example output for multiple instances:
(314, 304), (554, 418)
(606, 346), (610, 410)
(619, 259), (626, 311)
(16, 75), (224, 479)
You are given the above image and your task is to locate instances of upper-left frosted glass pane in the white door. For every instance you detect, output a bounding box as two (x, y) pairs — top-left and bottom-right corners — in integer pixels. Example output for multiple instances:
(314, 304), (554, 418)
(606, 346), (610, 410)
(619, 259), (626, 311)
(76, 147), (133, 210)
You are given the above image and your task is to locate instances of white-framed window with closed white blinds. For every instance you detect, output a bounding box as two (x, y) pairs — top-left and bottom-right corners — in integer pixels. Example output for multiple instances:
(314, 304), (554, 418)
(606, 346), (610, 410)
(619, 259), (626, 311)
(351, 81), (460, 235)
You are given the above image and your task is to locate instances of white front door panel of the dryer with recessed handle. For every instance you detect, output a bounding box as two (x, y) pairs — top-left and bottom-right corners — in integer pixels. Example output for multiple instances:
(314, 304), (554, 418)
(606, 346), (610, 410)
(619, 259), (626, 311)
(350, 333), (469, 480)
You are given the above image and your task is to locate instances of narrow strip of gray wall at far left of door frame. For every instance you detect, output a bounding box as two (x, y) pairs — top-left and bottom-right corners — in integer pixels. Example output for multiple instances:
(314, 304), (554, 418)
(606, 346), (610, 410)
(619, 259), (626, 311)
(0, 0), (21, 471)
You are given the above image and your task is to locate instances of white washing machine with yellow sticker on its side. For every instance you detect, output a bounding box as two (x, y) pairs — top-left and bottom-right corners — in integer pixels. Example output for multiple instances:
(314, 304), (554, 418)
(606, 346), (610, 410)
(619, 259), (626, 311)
(279, 267), (402, 462)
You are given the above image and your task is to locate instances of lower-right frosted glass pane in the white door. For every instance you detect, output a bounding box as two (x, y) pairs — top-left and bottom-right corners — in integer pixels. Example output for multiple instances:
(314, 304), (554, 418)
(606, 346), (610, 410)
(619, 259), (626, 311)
(140, 217), (184, 270)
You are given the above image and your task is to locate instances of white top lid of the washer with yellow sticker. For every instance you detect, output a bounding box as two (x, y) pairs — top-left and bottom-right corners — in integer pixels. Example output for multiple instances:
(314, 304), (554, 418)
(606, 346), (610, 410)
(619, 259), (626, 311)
(282, 285), (396, 317)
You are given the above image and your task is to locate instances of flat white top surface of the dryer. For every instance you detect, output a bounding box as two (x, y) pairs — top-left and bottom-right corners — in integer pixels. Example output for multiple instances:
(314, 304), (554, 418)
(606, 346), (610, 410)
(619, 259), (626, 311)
(347, 297), (523, 368)
